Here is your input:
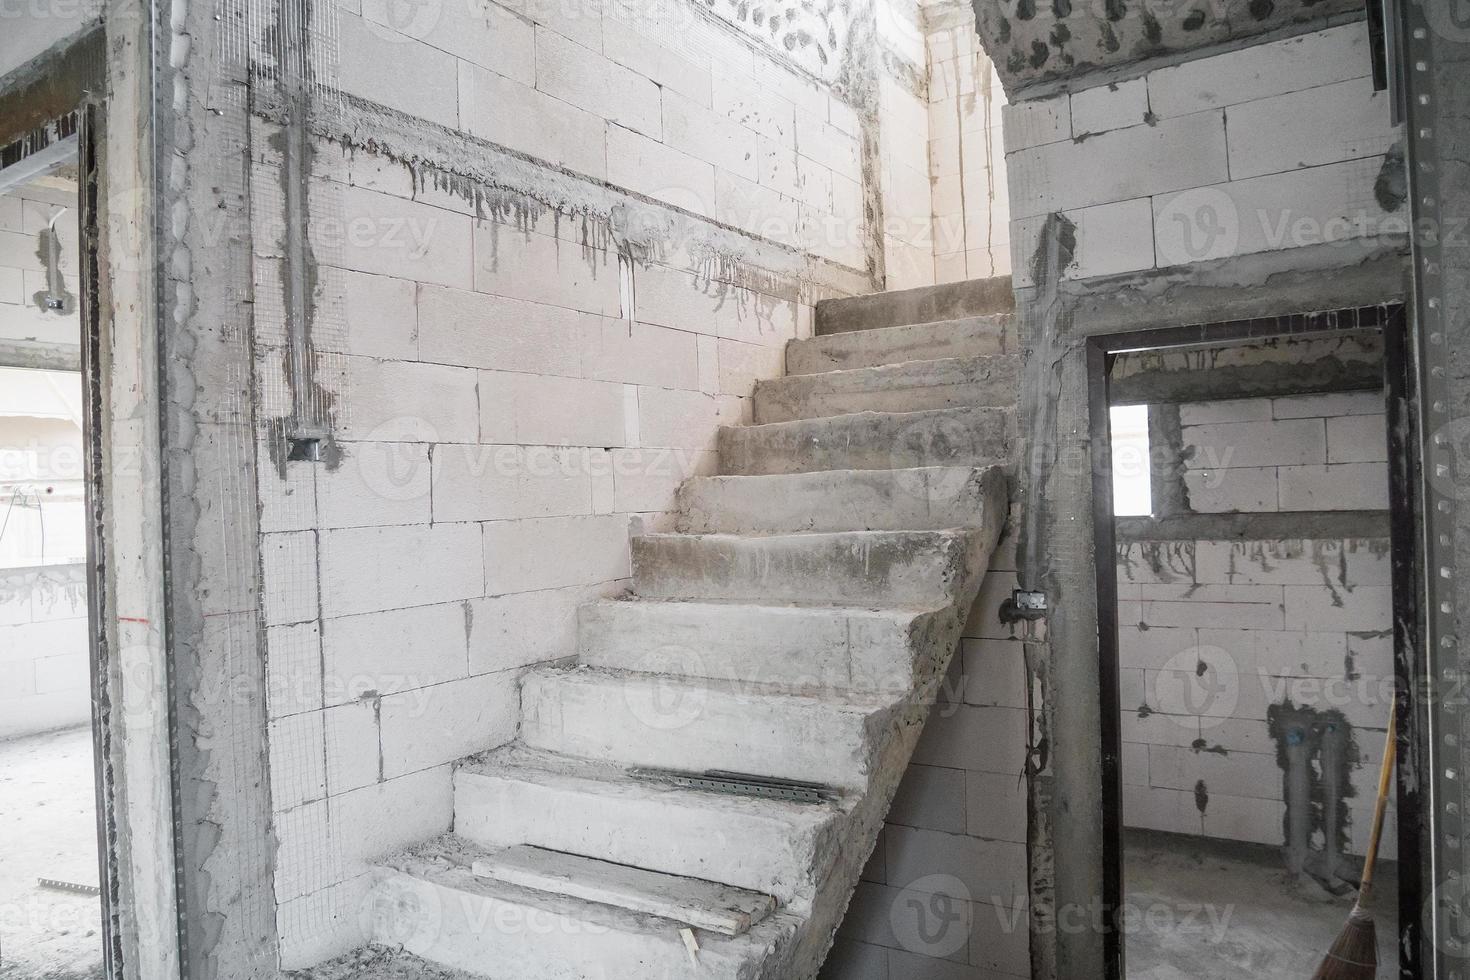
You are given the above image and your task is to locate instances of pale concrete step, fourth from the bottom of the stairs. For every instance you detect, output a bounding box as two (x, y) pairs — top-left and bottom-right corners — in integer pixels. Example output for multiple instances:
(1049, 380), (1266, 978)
(578, 599), (939, 695)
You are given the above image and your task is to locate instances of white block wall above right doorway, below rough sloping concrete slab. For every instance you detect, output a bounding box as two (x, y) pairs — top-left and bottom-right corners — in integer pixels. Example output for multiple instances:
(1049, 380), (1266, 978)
(1005, 24), (1407, 285)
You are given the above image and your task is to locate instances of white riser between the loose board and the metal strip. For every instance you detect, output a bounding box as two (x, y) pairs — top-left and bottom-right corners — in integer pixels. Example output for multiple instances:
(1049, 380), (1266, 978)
(454, 771), (841, 909)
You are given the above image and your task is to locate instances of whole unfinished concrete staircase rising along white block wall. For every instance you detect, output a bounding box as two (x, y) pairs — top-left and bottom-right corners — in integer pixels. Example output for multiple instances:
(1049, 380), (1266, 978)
(355, 279), (1019, 980)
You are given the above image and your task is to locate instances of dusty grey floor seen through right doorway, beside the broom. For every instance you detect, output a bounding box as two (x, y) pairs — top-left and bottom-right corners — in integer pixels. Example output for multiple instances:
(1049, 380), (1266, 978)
(1125, 836), (1398, 980)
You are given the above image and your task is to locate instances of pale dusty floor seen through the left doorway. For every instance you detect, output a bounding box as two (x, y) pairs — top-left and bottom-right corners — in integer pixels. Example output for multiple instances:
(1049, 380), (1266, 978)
(0, 729), (101, 980)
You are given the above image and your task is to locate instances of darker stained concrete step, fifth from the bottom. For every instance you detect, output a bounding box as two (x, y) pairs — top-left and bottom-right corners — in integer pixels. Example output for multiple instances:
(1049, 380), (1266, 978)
(632, 530), (976, 607)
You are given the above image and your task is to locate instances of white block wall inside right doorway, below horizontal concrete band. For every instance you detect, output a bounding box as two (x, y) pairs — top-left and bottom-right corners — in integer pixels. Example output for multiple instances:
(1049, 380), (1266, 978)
(1119, 539), (1394, 857)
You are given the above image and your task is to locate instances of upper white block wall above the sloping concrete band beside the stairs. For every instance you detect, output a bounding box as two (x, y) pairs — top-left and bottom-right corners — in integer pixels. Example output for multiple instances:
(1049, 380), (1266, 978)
(326, 0), (933, 283)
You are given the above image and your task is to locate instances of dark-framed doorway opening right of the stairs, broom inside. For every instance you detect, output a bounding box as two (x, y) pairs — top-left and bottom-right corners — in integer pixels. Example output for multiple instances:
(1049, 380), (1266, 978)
(1092, 307), (1420, 980)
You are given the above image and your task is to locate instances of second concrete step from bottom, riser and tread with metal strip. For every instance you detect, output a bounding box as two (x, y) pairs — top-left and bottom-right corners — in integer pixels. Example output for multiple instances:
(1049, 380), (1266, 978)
(454, 743), (848, 911)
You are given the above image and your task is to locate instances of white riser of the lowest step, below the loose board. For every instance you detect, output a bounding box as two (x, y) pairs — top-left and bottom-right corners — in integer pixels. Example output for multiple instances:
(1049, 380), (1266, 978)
(370, 871), (789, 980)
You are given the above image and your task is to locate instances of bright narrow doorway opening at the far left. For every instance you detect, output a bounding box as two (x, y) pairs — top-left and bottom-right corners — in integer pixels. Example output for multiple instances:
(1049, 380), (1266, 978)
(0, 140), (106, 980)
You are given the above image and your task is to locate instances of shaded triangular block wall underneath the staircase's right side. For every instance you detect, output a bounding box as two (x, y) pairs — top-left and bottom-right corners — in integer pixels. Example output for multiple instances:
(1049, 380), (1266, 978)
(823, 516), (1038, 980)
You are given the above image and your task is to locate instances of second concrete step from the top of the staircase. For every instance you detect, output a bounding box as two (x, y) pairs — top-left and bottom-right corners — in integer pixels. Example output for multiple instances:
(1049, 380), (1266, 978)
(786, 313), (1020, 375)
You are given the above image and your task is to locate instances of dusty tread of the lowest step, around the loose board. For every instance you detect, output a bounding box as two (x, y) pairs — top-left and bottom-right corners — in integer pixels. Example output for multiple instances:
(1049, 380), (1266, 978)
(379, 833), (804, 954)
